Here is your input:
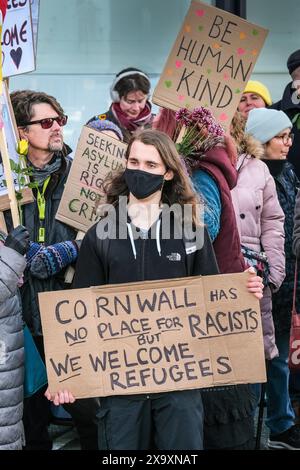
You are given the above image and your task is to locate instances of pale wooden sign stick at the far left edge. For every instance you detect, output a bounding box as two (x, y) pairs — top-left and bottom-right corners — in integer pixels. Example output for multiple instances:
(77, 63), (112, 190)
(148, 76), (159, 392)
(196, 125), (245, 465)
(0, 125), (20, 228)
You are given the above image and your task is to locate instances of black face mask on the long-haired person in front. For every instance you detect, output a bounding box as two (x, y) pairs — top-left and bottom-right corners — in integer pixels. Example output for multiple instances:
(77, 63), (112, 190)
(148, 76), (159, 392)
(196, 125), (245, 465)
(124, 168), (164, 199)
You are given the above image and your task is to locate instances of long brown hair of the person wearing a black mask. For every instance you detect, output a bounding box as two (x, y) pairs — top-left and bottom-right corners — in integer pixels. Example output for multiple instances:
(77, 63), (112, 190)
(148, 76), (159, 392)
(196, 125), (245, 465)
(104, 129), (199, 225)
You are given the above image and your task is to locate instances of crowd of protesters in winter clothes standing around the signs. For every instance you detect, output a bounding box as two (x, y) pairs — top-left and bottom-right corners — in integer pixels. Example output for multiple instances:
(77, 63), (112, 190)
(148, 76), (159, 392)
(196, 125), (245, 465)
(0, 50), (300, 450)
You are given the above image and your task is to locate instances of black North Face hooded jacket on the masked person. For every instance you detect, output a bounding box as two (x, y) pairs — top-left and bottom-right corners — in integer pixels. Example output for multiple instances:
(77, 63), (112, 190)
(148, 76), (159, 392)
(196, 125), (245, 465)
(73, 211), (219, 288)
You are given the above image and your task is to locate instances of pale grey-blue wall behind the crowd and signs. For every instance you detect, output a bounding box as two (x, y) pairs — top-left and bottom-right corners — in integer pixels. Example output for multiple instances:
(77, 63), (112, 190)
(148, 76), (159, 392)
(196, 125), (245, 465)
(10, 0), (300, 148)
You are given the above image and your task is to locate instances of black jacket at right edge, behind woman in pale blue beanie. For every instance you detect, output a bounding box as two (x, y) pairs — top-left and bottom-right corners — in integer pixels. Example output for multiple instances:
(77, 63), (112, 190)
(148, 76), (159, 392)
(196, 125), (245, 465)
(270, 82), (300, 179)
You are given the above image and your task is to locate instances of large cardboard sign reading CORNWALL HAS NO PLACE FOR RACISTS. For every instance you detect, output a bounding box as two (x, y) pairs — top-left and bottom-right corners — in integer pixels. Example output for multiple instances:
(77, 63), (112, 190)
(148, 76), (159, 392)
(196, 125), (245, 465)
(39, 273), (266, 398)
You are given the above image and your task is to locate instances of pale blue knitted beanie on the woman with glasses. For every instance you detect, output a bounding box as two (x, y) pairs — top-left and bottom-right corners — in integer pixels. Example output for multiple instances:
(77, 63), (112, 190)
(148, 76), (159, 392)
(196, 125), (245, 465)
(245, 108), (293, 144)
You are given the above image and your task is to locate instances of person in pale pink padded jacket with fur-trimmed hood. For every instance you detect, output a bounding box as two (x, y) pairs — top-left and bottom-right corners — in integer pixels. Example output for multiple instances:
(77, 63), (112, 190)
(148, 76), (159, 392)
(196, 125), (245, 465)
(231, 113), (285, 359)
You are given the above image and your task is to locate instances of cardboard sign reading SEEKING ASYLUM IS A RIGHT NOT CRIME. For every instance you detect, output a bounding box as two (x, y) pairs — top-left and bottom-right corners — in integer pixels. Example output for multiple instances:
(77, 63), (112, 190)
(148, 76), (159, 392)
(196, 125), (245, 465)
(56, 126), (127, 232)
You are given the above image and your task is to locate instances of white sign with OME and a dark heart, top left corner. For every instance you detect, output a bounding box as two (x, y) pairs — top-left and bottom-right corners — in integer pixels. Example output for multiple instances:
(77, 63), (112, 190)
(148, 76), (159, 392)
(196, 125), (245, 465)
(2, 0), (35, 77)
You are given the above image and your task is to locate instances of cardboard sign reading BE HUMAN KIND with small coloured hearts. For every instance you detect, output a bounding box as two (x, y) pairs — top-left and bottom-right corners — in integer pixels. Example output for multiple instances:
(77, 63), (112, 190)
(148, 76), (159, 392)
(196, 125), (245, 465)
(152, 1), (268, 129)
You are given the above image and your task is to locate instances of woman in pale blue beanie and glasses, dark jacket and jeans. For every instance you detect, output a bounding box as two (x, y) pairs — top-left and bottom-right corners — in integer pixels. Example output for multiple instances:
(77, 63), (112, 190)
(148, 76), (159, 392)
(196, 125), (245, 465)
(246, 108), (300, 450)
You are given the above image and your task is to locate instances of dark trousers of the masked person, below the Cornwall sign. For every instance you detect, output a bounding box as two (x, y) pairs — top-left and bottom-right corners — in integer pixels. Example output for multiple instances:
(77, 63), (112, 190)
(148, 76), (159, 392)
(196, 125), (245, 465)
(98, 390), (203, 450)
